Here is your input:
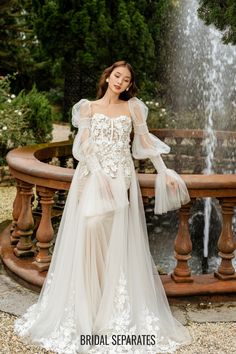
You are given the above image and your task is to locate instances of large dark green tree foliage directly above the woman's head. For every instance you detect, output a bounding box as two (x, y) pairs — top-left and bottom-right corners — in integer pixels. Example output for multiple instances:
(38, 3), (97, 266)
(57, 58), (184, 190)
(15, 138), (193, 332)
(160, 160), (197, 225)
(29, 0), (171, 75)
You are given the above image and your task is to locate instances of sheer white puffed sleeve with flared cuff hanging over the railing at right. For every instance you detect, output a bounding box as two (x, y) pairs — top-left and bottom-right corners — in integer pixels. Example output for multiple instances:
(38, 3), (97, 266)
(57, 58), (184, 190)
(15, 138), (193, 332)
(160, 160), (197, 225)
(129, 98), (190, 214)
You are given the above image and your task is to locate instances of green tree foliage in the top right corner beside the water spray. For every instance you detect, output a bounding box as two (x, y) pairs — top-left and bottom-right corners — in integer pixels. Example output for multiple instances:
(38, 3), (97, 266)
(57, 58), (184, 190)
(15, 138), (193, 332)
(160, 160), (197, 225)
(198, 0), (236, 44)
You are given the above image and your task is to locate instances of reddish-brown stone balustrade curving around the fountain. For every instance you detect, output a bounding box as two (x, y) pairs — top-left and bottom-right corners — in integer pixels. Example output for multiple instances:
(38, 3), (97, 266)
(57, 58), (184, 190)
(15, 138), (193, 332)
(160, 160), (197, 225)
(0, 130), (236, 296)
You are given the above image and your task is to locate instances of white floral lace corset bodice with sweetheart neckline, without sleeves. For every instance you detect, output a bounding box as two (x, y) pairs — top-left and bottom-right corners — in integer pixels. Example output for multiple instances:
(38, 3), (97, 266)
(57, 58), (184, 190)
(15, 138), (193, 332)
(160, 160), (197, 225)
(81, 113), (132, 184)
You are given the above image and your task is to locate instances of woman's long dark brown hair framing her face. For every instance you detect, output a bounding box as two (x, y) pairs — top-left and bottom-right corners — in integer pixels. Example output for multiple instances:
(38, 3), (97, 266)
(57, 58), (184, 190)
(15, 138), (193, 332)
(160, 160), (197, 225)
(97, 60), (137, 101)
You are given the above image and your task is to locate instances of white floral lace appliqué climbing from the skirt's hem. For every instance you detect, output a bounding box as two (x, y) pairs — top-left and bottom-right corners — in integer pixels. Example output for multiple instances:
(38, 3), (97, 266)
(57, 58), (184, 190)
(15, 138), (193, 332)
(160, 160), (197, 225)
(14, 271), (179, 354)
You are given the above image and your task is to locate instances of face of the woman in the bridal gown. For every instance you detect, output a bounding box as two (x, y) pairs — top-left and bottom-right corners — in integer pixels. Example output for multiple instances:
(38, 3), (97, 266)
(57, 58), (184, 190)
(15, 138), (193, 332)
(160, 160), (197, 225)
(108, 66), (131, 95)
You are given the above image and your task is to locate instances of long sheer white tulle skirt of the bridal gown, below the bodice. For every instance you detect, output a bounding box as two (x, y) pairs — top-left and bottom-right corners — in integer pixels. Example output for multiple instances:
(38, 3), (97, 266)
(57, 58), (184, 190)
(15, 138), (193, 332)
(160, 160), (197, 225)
(14, 165), (190, 354)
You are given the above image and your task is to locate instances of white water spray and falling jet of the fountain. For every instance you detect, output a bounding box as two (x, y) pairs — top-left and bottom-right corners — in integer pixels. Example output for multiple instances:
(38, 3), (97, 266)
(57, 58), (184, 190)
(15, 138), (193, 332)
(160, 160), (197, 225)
(168, 0), (236, 272)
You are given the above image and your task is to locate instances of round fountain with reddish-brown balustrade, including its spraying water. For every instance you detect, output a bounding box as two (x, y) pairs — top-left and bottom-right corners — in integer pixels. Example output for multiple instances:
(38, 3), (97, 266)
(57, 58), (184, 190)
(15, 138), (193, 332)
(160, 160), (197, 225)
(0, 0), (236, 297)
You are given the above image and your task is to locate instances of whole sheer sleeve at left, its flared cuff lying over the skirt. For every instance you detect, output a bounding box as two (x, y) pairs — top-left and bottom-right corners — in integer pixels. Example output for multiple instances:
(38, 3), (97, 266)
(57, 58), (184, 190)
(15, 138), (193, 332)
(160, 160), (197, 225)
(72, 99), (127, 217)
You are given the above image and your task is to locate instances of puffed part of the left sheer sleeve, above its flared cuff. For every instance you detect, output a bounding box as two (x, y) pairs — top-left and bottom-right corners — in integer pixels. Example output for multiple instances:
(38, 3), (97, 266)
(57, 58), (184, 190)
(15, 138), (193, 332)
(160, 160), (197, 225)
(72, 99), (101, 173)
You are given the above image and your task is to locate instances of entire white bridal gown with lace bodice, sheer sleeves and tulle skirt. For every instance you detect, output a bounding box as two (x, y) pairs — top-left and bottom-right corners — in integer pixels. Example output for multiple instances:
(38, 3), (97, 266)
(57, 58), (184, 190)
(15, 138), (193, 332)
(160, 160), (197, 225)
(14, 98), (190, 354)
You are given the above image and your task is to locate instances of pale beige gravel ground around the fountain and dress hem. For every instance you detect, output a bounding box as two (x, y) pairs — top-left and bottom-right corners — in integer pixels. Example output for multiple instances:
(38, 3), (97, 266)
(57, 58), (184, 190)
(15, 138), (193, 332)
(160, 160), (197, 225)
(0, 171), (236, 354)
